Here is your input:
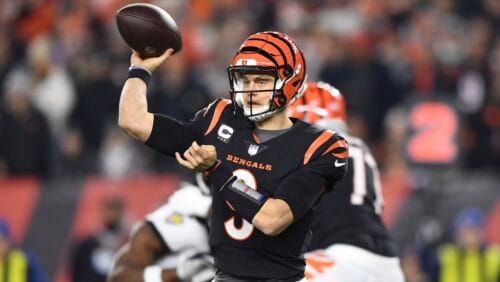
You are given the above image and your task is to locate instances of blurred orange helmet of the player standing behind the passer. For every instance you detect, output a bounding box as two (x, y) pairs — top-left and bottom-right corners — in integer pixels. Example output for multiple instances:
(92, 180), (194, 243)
(289, 81), (347, 132)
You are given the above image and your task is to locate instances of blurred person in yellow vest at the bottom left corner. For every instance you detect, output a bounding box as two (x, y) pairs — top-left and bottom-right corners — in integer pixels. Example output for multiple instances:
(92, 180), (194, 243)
(0, 217), (47, 282)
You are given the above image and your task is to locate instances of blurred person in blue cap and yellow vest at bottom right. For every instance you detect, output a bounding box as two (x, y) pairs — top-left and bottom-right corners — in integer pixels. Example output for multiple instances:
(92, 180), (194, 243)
(430, 208), (500, 282)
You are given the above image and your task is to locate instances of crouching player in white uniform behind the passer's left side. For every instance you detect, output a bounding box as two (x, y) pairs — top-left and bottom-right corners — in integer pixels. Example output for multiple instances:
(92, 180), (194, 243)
(108, 176), (215, 282)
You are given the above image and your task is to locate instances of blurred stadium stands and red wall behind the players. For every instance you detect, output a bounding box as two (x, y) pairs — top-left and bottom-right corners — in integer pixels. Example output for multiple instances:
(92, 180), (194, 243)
(0, 0), (500, 282)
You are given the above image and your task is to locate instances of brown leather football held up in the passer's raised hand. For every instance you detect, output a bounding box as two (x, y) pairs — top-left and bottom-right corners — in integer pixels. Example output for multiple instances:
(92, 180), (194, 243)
(116, 3), (182, 58)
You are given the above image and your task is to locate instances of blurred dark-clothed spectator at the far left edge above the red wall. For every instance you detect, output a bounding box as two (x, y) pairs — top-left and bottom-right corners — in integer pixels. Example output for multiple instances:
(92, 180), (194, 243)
(0, 69), (51, 177)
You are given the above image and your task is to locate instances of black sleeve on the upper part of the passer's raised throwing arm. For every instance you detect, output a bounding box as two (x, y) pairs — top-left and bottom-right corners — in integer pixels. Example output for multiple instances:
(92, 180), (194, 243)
(145, 114), (203, 156)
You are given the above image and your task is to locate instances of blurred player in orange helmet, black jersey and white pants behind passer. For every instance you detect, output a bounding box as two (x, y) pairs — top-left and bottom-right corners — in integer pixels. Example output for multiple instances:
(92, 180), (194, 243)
(290, 82), (403, 282)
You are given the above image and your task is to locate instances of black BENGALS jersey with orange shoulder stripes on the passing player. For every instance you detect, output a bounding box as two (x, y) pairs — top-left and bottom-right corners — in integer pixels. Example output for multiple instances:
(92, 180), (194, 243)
(147, 99), (347, 280)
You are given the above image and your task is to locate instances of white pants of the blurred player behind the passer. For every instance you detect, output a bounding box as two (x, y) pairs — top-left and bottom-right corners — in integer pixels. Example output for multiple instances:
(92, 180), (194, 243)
(305, 244), (404, 282)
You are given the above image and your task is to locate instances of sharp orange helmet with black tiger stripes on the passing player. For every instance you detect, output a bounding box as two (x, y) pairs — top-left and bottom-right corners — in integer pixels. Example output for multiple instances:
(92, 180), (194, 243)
(227, 31), (306, 122)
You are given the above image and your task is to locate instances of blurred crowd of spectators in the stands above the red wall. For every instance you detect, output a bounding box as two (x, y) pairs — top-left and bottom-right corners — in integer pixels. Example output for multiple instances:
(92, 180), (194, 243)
(0, 0), (500, 281)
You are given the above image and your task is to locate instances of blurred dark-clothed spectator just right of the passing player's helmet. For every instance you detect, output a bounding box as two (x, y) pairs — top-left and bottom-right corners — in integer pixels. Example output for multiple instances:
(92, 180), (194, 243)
(319, 30), (401, 145)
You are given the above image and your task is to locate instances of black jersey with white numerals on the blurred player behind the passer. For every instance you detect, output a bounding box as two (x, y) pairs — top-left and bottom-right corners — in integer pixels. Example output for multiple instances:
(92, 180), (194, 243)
(309, 135), (396, 256)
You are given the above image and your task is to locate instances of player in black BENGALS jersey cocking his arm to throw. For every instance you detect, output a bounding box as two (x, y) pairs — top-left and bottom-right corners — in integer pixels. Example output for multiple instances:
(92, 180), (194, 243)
(119, 32), (348, 281)
